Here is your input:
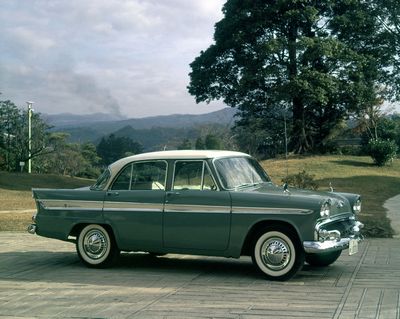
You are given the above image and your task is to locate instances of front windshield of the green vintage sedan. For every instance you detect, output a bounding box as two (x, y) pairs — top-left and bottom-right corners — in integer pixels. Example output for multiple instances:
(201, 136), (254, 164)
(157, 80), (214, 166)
(214, 157), (270, 189)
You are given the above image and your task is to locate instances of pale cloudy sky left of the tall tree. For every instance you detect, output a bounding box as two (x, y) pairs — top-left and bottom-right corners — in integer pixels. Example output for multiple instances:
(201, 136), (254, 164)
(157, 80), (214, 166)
(0, 0), (225, 118)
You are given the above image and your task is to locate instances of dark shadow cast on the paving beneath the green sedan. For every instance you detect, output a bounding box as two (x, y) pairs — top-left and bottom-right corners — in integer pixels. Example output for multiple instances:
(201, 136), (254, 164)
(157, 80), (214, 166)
(0, 251), (338, 287)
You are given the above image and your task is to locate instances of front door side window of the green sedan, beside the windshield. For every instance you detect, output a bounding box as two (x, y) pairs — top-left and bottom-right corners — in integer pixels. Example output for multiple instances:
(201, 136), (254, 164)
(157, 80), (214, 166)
(173, 161), (217, 190)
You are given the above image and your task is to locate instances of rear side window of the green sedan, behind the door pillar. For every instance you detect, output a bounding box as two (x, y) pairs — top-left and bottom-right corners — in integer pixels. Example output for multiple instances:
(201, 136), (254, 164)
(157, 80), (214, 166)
(112, 161), (167, 190)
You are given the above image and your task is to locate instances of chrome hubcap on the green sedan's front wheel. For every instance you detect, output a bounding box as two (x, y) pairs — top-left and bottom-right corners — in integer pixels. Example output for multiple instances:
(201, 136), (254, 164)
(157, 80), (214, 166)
(261, 238), (291, 270)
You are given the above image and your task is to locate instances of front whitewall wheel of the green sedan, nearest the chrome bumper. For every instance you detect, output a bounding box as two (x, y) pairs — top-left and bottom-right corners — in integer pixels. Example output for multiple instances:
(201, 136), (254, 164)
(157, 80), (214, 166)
(252, 227), (304, 280)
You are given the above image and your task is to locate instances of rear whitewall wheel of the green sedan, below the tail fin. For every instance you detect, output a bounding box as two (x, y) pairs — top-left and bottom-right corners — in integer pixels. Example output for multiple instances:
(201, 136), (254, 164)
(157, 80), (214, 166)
(76, 224), (118, 268)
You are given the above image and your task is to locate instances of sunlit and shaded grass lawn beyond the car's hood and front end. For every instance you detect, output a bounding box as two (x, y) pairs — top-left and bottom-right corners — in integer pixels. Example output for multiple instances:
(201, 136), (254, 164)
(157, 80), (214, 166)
(262, 156), (400, 237)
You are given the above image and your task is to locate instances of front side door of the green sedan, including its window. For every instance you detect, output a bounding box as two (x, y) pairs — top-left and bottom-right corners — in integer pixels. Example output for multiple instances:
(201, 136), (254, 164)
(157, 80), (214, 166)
(163, 160), (231, 251)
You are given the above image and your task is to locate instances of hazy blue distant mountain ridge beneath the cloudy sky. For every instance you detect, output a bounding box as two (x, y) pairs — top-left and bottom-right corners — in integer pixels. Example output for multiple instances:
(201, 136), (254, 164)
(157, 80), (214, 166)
(47, 108), (236, 149)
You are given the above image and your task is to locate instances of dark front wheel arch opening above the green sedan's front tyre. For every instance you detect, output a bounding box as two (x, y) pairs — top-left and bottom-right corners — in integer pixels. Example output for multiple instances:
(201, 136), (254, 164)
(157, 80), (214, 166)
(241, 219), (301, 256)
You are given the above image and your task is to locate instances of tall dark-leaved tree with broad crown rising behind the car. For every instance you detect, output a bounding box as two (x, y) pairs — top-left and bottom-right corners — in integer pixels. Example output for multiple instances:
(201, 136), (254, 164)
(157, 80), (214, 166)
(188, 0), (400, 153)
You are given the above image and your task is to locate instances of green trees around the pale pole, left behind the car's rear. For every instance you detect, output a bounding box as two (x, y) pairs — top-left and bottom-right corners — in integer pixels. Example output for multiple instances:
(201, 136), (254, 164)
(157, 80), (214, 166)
(0, 100), (142, 178)
